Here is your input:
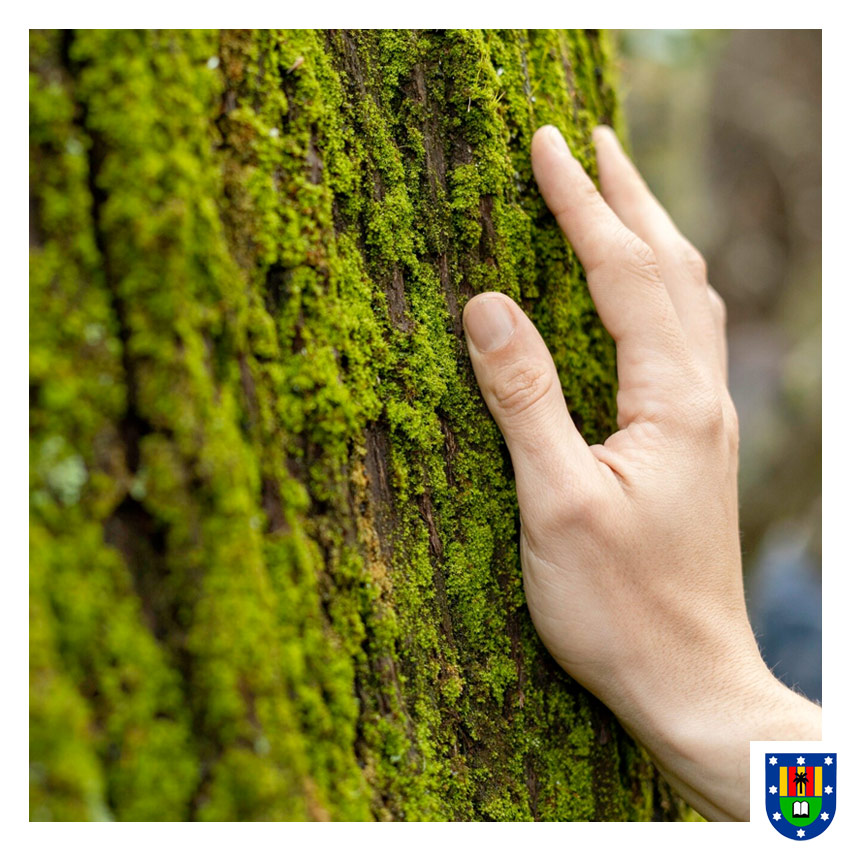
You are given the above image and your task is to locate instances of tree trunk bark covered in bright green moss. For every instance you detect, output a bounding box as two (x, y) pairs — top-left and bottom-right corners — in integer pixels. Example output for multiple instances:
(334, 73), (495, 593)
(30, 31), (681, 820)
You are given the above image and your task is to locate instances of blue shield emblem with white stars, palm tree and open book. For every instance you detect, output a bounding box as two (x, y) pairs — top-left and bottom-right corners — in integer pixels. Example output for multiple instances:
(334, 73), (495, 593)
(764, 753), (836, 841)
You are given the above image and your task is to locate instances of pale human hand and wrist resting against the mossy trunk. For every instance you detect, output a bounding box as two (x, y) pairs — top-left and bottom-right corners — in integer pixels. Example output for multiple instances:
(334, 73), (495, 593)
(463, 122), (821, 820)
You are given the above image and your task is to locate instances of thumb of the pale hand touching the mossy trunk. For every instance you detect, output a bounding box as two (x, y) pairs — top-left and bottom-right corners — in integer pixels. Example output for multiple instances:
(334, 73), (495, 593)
(463, 292), (596, 513)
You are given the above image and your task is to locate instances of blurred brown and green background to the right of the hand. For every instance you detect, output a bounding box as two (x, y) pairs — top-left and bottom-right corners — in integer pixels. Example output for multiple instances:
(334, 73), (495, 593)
(616, 30), (821, 700)
